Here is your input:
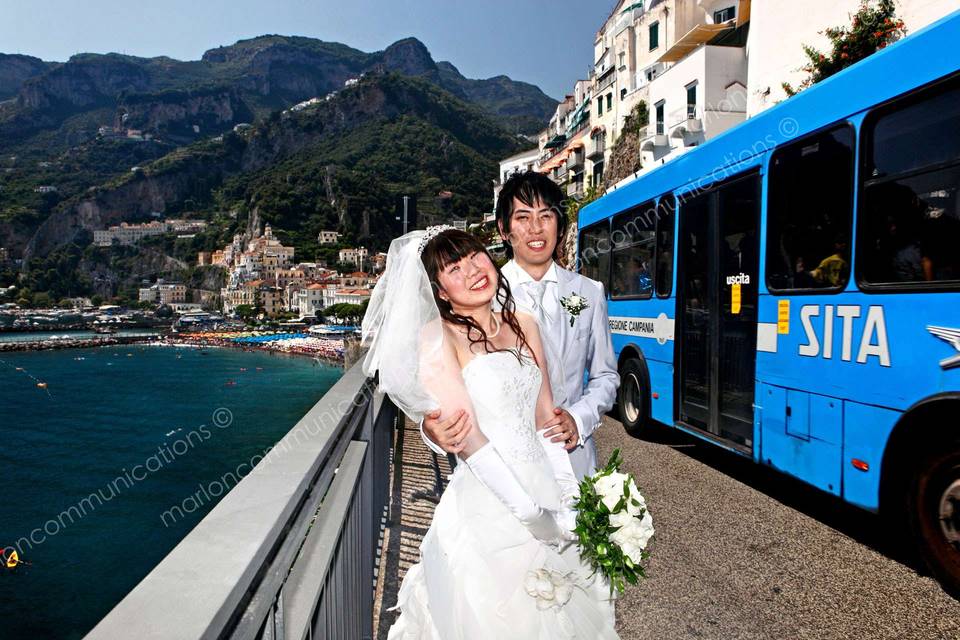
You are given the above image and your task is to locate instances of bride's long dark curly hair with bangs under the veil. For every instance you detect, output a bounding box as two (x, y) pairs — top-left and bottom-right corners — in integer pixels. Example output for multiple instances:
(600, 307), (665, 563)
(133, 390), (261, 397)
(420, 229), (536, 363)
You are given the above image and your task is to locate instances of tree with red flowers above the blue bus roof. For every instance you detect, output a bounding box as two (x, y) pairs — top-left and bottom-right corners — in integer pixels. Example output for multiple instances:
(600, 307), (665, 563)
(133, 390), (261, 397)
(781, 0), (907, 96)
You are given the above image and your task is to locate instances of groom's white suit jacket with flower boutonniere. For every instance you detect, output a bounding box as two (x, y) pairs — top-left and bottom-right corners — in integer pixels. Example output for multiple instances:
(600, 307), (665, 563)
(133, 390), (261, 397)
(421, 260), (620, 479)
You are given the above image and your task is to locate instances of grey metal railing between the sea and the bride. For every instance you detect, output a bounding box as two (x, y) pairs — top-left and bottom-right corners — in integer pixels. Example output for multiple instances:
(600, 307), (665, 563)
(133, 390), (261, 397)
(87, 363), (397, 640)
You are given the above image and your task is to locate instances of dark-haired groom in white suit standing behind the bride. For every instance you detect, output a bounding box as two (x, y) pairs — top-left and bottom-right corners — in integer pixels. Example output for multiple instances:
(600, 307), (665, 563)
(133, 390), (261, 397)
(422, 171), (620, 480)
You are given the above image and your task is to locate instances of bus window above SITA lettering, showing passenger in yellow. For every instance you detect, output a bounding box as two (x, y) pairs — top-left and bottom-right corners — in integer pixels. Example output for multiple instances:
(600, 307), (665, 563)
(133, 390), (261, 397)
(767, 125), (854, 292)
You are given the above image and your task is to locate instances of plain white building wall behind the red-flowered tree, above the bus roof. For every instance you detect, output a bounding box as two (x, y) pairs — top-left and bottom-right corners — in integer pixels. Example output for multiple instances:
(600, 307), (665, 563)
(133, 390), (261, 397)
(747, 0), (960, 116)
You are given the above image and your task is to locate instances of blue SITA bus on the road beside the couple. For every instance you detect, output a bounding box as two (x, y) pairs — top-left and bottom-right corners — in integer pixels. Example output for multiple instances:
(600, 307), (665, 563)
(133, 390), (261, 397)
(578, 12), (960, 595)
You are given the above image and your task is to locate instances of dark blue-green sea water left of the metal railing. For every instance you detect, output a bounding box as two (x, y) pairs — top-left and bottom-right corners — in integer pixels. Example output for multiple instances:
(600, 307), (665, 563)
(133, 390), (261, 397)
(0, 345), (342, 640)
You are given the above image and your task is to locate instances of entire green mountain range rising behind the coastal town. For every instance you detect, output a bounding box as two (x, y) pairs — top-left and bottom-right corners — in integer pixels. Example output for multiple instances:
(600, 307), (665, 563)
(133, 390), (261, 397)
(0, 35), (556, 304)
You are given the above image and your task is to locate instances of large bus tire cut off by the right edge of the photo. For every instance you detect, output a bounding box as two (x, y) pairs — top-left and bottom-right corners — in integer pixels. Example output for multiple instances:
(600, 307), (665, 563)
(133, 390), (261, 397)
(907, 440), (960, 598)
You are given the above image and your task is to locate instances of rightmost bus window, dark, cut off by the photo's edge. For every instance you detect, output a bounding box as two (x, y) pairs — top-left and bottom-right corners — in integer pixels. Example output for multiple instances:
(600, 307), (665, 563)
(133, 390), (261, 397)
(857, 80), (960, 288)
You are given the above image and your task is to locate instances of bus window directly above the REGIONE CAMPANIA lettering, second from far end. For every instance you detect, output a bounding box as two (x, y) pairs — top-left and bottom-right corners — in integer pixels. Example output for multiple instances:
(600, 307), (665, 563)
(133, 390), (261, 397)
(610, 202), (657, 298)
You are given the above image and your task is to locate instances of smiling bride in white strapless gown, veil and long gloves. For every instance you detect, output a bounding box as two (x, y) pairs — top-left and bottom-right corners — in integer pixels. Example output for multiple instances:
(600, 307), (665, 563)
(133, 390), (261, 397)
(363, 227), (618, 640)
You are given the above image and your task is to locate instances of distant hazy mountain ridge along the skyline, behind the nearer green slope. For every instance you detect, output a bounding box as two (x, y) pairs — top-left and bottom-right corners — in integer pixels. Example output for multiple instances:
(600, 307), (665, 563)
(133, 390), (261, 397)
(0, 35), (556, 155)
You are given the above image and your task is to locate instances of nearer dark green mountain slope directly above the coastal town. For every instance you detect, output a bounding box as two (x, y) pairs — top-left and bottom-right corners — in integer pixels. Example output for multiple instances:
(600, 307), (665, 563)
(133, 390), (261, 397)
(3, 72), (519, 299)
